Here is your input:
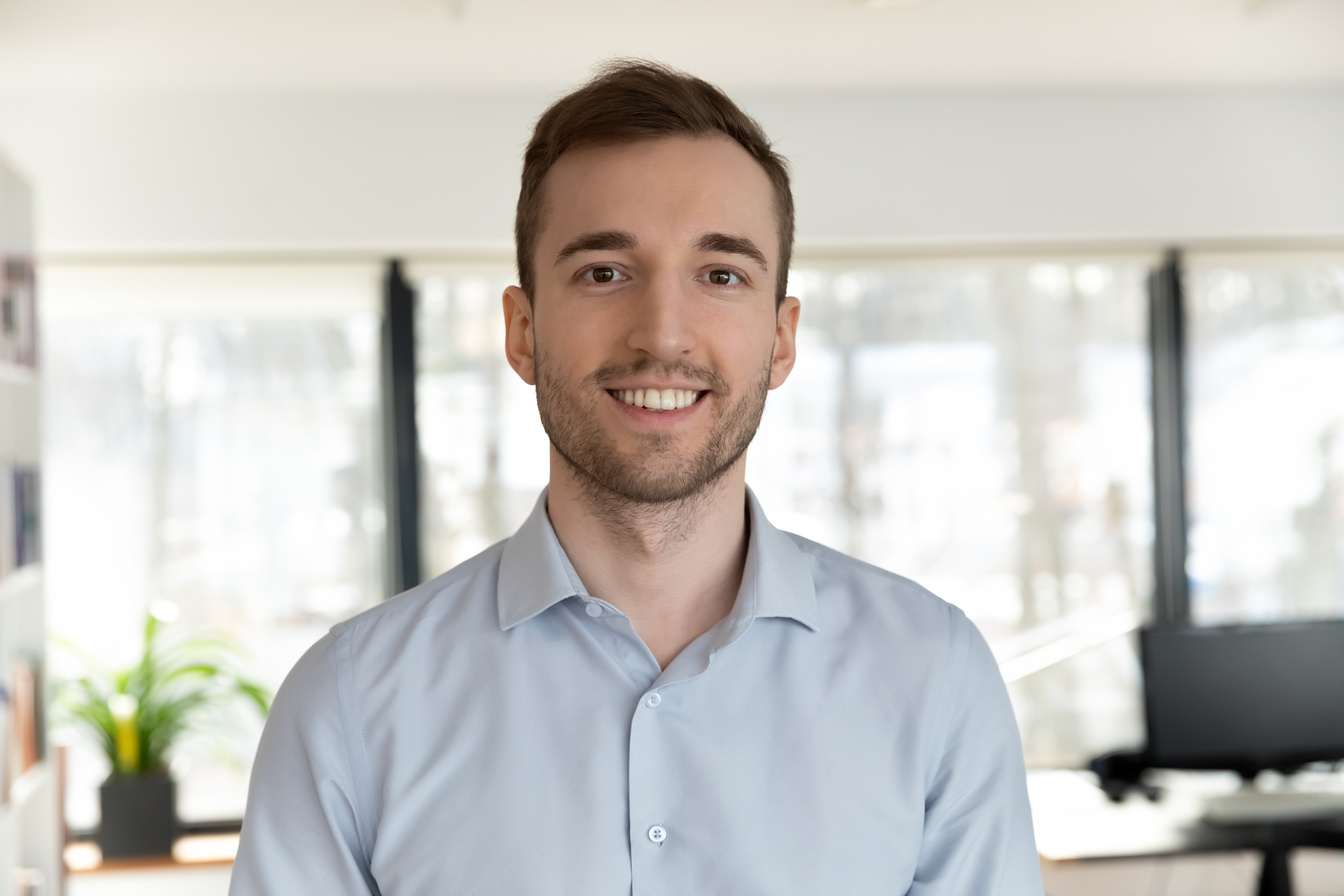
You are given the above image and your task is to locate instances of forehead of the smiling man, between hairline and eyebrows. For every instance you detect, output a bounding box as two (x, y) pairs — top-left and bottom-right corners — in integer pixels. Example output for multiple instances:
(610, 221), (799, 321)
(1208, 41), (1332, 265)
(538, 136), (778, 260)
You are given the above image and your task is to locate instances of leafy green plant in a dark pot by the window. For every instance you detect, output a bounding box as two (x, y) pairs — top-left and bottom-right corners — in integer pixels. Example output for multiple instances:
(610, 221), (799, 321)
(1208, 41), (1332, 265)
(56, 603), (270, 858)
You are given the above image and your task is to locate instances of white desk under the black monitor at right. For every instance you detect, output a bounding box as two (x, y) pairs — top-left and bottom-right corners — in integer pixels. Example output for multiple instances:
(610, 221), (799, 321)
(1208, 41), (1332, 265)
(1027, 771), (1344, 896)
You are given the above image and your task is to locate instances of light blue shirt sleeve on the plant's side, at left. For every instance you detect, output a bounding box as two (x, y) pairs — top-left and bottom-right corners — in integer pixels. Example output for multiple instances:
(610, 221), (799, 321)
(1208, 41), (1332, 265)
(228, 634), (379, 896)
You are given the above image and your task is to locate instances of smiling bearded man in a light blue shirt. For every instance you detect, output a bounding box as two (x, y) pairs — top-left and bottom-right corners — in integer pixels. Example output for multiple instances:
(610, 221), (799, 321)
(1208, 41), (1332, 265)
(231, 62), (1040, 896)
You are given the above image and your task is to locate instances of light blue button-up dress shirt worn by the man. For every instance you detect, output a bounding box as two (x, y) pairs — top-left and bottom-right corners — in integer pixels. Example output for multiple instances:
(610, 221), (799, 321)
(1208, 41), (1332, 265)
(230, 494), (1042, 896)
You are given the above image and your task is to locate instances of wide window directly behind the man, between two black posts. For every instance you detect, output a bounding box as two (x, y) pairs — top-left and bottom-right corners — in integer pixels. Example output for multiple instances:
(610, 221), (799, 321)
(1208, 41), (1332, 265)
(414, 258), (1152, 764)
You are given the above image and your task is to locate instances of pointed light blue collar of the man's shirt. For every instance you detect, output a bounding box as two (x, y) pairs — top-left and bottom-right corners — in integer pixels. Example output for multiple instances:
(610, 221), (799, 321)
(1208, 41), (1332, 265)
(497, 489), (818, 631)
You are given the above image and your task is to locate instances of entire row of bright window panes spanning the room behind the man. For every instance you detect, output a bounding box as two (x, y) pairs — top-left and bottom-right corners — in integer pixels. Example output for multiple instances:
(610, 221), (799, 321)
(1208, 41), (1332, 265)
(42, 255), (1344, 827)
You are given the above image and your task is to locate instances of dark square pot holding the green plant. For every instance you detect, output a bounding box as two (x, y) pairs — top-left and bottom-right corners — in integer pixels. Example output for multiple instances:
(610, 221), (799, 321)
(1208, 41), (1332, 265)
(98, 772), (177, 858)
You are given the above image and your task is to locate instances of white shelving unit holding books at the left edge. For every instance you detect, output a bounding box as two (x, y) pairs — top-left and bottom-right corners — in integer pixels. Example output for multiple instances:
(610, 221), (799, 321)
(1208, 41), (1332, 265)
(0, 150), (62, 896)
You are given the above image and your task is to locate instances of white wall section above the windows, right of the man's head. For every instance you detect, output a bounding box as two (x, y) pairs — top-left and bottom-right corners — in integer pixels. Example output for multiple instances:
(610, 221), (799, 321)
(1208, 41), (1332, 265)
(755, 91), (1344, 247)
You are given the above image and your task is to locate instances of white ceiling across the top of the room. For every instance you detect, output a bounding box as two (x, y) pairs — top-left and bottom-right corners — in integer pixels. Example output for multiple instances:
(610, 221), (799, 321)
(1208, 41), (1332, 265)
(0, 0), (1344, 94)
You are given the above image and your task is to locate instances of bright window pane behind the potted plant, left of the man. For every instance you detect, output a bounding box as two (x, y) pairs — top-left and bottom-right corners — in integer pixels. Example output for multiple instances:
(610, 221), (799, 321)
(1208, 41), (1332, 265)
(40, 265), (386, 827)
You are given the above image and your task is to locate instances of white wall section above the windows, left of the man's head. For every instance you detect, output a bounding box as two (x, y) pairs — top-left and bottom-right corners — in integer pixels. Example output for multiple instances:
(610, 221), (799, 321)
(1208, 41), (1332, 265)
(0, 97), (538, 251)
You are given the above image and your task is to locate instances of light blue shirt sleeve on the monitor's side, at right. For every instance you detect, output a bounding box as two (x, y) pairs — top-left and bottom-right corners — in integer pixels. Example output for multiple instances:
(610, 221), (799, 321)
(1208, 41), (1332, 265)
(909, 611), (1043, 896)
